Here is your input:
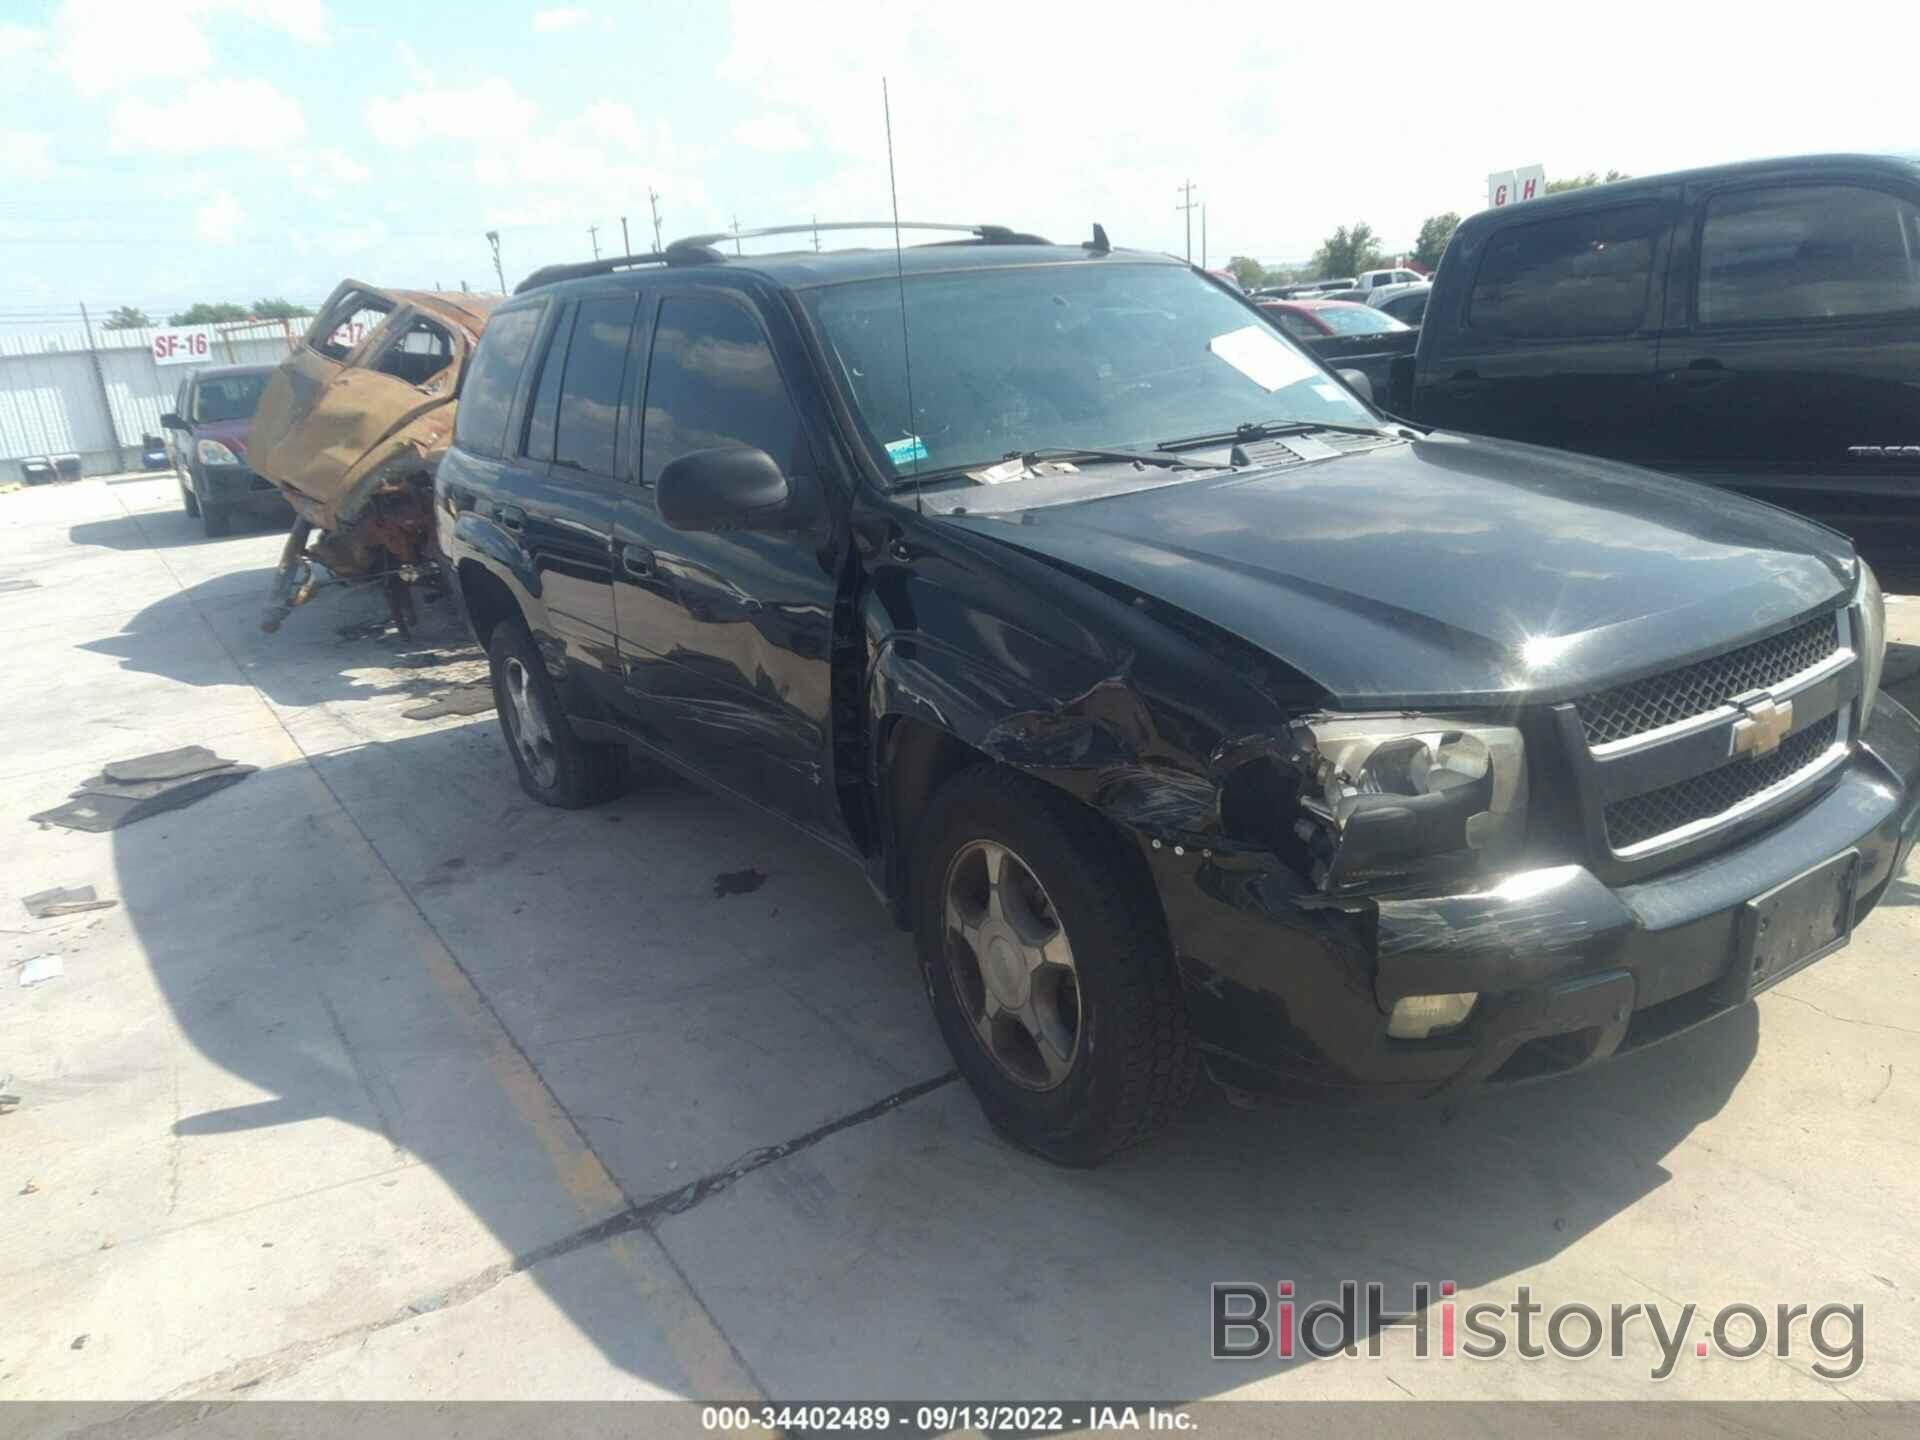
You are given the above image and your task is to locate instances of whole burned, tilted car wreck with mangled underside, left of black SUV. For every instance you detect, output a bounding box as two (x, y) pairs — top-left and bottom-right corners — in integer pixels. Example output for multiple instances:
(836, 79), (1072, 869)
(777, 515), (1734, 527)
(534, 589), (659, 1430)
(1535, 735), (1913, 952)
(252, 280), (497, 632)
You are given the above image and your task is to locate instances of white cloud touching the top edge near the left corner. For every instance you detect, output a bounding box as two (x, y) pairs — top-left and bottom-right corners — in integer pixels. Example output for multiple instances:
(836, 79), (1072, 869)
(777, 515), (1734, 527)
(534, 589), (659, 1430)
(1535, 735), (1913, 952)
(54, 0), (328, 96)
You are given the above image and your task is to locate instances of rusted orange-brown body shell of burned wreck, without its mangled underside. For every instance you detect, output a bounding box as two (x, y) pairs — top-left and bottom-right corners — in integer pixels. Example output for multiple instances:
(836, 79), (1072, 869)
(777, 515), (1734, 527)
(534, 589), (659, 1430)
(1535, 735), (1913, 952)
(252, 280), (499, 536)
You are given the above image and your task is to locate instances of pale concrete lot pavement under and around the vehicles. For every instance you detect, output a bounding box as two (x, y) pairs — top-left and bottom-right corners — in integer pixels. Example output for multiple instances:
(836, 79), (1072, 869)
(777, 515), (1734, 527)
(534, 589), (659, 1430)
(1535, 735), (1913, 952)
(0, 478), (1920, 1402)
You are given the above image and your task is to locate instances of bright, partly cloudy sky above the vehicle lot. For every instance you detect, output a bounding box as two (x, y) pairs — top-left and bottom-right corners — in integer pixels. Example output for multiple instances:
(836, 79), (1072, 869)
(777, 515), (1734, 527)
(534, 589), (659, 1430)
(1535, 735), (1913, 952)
(0, 0), (1920, 328)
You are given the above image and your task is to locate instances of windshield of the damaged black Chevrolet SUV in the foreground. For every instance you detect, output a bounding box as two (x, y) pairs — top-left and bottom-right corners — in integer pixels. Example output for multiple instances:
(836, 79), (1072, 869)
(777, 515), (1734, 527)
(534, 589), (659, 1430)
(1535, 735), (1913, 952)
(803, 261), (1373, 476)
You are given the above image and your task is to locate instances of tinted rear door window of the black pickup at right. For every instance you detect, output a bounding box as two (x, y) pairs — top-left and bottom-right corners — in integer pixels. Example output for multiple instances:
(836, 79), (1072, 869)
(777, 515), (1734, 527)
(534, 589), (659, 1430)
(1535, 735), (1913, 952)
(1467, 205), (1665, 340)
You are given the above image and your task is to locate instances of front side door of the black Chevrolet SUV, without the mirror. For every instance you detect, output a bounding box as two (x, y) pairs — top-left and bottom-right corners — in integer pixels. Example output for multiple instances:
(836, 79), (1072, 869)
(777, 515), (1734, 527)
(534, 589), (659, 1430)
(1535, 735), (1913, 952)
(614, 288), (845, 845)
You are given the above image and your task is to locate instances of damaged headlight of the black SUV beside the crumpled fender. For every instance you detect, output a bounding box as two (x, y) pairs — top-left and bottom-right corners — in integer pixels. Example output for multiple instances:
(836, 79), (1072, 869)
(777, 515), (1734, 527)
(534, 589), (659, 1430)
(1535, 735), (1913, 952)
(1298, 714), (1526, 889)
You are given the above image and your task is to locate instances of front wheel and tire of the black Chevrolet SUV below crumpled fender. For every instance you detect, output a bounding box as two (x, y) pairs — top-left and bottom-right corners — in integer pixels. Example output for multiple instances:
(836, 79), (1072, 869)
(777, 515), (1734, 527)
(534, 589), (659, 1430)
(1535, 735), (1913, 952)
(914, 764), (1200, 1165)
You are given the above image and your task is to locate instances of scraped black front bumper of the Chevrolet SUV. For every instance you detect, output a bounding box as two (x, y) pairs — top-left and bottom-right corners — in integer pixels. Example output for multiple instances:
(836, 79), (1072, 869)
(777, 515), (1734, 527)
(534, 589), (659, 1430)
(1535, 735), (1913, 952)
(1148, 697), (1920, 1100)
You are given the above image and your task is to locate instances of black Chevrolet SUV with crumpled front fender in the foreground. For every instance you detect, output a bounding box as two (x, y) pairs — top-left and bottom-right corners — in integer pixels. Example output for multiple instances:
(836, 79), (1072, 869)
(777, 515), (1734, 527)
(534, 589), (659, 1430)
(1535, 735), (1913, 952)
(436, 227), (1920, 1164)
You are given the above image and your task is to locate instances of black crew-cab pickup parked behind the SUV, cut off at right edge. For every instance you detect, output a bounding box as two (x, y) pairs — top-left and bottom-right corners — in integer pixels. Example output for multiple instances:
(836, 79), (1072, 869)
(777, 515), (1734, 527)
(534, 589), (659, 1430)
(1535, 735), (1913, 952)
(1394, 156), (1920, 541)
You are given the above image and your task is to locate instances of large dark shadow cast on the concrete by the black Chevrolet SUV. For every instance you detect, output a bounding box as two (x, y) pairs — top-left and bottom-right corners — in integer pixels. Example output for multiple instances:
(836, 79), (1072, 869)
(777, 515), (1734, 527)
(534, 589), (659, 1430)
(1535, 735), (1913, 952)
(113, 724), (1759, 1398)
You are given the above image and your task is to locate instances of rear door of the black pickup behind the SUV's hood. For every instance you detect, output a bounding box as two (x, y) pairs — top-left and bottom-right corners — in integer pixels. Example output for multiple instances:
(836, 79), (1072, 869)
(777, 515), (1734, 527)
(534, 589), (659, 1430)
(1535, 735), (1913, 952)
(1415, 194), (1678, 459)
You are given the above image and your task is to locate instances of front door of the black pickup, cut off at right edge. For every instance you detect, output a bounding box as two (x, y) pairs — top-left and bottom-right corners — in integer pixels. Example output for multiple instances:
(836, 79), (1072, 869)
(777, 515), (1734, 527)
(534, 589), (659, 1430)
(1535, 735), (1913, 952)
(1649, 169), (1920, 532)
